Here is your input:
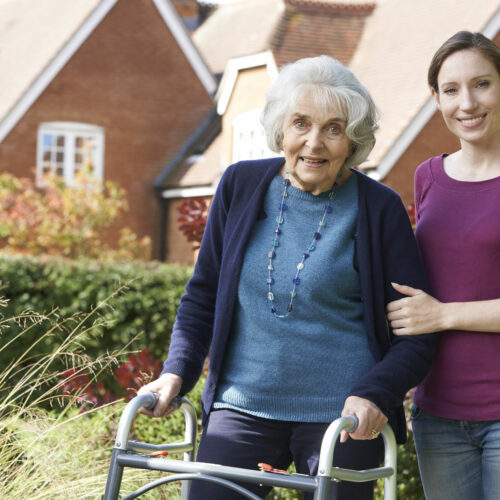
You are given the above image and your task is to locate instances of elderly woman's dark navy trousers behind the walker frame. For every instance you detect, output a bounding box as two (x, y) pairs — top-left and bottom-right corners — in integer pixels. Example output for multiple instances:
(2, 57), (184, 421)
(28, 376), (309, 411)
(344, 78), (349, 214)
(189, 410), (384, 500)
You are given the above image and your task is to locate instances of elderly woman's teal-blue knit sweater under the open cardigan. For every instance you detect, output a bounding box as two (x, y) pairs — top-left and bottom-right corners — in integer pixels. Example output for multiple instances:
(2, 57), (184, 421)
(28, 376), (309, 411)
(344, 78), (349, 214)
(214, 174), (374, 422)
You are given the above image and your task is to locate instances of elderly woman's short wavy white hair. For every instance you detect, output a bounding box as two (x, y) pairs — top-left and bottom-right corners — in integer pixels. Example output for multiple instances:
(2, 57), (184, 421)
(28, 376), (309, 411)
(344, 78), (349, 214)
(261, 55), (378, 167)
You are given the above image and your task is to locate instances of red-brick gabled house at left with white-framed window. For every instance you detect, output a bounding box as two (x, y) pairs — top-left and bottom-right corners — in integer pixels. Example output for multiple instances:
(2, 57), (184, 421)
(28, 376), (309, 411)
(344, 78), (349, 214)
(0, 0), (216, 257)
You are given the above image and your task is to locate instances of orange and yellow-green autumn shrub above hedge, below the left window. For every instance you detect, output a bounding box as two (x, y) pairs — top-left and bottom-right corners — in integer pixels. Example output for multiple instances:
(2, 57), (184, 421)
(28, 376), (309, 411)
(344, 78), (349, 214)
(0, 170), (151, 260)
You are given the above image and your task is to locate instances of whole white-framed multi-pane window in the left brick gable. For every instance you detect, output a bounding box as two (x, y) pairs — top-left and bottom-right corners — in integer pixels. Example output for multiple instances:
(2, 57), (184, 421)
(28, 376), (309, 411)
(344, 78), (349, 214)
(36, 122), (104, 186)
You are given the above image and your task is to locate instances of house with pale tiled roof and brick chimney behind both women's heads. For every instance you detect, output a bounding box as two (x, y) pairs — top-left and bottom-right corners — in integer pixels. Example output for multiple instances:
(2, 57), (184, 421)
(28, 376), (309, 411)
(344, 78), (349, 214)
(162, 0), (500, 262)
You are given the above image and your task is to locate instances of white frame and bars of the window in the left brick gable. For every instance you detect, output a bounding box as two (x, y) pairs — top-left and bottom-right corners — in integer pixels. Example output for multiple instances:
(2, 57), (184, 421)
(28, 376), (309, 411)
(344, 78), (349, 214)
(36, 122), (104, 186)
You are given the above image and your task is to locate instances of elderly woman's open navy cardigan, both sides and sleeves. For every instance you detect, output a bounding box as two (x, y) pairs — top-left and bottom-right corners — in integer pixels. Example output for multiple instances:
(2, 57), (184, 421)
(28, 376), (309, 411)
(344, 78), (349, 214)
(163, 158), (436, 442)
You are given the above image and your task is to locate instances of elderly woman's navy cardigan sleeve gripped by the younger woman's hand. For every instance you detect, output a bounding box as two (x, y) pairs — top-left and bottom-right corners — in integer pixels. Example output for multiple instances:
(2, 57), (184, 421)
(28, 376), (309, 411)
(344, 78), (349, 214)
(350, 188), (437, 437)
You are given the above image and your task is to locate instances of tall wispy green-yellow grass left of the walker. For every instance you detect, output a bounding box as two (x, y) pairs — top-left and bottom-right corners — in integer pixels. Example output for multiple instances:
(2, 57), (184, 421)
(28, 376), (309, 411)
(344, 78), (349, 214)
(0, 290), (186, 500)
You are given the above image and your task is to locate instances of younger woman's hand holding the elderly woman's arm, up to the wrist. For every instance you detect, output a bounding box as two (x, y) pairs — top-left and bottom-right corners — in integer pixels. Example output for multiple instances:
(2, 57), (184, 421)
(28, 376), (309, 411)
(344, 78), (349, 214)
(387, 283), (447, 335)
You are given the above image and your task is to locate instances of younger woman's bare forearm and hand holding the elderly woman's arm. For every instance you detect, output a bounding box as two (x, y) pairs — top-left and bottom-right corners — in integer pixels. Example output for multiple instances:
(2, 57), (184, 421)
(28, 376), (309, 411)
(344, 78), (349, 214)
(387, 283), (500, 335)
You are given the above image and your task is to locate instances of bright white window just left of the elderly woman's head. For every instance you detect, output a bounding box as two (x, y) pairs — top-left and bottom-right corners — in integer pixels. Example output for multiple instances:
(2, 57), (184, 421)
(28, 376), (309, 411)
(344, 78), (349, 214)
(232, 109), (279, 163)
